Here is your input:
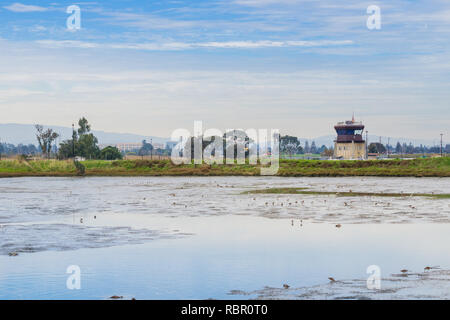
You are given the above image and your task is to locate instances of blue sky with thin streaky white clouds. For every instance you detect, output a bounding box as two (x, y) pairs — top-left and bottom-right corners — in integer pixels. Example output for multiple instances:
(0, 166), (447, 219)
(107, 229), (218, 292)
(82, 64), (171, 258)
(0, 0), (450, 140)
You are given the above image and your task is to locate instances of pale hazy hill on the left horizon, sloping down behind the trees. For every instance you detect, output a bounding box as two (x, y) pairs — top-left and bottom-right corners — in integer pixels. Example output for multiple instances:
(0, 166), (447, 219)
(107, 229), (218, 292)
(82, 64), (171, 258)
(0, 123), (169, 145)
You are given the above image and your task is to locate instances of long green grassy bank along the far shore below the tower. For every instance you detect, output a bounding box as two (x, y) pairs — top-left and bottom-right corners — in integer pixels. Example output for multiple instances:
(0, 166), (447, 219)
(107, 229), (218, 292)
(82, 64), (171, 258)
(0, 157), (450, 177)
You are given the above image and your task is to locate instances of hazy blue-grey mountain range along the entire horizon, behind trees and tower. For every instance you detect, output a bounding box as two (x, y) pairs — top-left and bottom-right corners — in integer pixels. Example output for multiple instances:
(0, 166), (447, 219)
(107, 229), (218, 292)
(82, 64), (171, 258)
(0, 123), (440, 147)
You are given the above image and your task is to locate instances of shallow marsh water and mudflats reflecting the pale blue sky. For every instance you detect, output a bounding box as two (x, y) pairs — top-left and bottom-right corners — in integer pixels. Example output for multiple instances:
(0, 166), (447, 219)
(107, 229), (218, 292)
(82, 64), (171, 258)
(0, 177), (450, 299)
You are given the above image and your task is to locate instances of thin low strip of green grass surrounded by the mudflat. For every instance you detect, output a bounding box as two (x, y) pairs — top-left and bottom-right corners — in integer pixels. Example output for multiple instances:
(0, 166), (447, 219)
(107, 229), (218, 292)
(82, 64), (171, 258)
(243, 188), (450, 199)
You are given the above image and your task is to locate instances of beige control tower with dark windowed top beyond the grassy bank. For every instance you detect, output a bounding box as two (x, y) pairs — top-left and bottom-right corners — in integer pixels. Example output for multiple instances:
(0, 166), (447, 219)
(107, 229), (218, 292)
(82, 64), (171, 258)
(334, 116), (367, 160)
